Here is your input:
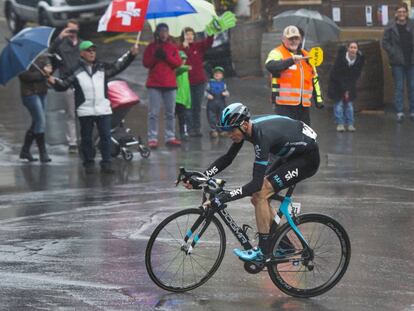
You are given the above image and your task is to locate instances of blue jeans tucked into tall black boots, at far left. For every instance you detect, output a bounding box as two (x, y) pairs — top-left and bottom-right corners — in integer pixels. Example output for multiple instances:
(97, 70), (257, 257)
(22, 95), (46, 134)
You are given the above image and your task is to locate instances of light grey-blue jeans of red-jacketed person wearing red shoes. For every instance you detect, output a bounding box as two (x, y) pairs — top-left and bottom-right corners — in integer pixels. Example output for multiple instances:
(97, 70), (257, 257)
(148, 88), (176, 141)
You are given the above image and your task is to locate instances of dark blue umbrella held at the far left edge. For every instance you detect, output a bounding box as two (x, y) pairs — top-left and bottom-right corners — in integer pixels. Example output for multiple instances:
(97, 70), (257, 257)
(0, 26), (55, 85)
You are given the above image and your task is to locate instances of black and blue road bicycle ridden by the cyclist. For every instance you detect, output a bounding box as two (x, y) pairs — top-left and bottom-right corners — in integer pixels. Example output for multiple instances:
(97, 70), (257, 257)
(145, 168), (351, 298)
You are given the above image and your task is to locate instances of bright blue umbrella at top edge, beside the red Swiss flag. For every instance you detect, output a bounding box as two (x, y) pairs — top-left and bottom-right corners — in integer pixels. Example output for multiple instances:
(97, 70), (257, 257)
(145, 0), (196, 19)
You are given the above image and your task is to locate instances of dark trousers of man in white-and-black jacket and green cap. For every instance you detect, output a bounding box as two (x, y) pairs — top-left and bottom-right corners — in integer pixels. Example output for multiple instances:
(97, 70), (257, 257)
(79, 114), (111, 166)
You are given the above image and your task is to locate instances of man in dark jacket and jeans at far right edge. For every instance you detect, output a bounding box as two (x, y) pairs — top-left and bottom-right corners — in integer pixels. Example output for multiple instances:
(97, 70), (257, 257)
(382, 2), (414, 122)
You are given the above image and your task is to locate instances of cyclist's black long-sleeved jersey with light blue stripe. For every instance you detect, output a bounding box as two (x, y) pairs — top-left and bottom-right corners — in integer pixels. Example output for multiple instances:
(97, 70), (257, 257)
(205, 115), (317, 203)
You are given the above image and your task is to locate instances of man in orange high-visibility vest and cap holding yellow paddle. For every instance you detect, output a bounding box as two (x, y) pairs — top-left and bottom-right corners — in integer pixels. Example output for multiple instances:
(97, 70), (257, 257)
(266, 25), (323, 125)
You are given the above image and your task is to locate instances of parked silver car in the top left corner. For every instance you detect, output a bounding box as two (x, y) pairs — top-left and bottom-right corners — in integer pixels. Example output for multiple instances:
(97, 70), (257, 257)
(4, 0), (111, 33)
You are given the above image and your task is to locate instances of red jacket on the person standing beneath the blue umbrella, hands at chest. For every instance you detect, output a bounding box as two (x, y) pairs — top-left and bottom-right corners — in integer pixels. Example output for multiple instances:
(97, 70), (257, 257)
(142, 41), (182, 88)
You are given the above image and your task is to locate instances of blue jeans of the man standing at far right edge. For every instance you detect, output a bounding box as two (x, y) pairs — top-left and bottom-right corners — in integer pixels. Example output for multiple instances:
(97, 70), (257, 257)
(392, 65), (414, 113)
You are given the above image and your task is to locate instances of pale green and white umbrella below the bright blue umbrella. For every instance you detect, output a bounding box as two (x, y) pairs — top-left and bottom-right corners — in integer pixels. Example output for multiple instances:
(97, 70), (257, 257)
(148, 0), (217, 37)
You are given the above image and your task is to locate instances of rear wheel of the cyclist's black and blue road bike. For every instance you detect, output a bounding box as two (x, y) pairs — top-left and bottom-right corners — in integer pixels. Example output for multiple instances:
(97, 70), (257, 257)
(268, 214), (351, 298)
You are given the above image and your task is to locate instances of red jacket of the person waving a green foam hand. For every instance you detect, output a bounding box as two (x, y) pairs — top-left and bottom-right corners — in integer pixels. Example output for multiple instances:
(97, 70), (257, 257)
(179, 37), (214, 85)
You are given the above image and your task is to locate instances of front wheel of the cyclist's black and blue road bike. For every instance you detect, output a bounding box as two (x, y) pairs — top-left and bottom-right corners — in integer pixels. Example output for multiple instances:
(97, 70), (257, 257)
(145, 209), (226, 292)
